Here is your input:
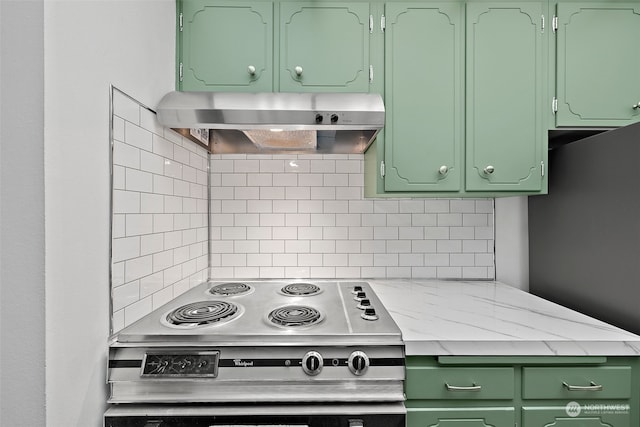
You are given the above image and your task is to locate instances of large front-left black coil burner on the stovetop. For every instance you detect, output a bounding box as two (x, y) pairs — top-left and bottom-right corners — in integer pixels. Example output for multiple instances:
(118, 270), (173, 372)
(166, 301), (240, 327)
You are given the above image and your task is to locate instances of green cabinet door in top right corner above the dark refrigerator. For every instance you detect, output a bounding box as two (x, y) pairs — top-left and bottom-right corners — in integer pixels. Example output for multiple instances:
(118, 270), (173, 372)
(556, 2), (640, 126)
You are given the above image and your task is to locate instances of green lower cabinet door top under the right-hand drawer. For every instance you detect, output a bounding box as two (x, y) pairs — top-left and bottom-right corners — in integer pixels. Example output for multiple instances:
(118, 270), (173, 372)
(522, 401), (632, 427)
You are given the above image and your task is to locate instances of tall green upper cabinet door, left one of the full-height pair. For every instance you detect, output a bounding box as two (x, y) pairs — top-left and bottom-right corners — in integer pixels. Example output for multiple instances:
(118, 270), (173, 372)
(384, 3), (464, 191)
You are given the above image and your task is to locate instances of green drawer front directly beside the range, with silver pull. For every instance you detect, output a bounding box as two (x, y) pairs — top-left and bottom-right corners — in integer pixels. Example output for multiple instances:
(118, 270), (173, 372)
(405, 367), (514, 399)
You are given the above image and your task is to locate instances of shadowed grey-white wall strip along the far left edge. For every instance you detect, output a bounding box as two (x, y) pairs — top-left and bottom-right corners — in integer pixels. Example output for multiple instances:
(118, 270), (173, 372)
(0, 0), (45, 427)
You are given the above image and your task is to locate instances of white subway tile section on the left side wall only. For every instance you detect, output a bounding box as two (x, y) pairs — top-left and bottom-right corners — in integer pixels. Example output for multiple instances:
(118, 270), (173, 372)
(111, 91), (209, 332)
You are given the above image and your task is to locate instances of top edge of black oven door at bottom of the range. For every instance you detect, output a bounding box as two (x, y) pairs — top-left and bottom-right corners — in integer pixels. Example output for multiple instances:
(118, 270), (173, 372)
(104, 402), (406, 427)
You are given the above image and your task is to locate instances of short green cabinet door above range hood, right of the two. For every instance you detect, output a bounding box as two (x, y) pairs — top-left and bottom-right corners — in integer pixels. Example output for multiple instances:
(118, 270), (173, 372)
(279, 2), (370, 92)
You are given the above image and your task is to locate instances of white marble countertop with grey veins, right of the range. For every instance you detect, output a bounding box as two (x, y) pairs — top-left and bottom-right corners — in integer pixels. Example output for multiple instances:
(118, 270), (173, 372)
(369, 279), (640, 356)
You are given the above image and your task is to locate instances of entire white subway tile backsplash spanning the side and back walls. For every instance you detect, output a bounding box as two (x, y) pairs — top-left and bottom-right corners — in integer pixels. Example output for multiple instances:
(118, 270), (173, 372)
(112, 94), (495, 328)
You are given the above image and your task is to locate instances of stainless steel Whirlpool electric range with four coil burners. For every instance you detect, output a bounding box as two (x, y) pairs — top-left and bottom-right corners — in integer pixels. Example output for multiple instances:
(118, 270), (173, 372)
(105, 281), (405, 427)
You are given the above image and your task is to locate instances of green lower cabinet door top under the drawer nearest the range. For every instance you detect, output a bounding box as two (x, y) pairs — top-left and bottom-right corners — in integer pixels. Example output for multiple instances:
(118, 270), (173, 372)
(407, 407), (516, 427)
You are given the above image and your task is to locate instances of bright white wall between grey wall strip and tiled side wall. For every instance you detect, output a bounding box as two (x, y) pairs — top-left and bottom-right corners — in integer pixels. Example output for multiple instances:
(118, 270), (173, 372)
(44, 0), (175, 427)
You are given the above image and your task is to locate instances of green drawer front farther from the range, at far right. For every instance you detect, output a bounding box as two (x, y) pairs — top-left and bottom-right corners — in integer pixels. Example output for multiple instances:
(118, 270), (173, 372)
(522, 366), (631, 399)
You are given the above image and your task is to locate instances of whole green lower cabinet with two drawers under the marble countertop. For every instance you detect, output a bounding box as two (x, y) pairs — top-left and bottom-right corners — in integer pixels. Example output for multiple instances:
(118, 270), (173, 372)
(405, 356), (640, 427)
